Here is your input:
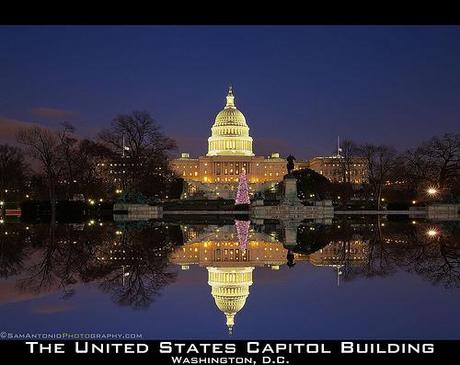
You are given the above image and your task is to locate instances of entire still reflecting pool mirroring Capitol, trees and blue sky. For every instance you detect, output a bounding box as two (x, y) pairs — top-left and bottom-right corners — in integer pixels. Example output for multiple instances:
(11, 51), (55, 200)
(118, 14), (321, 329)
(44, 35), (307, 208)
(0, 217), (460, 339)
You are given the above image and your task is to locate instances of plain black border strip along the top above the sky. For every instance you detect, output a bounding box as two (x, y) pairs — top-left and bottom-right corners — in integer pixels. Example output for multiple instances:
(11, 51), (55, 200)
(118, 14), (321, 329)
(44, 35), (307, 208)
(0, 5), (460, 25)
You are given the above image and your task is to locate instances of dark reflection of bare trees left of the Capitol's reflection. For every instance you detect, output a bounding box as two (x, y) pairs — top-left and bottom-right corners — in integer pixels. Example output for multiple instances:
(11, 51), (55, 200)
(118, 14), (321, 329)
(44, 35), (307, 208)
(0, 223), (182, 308)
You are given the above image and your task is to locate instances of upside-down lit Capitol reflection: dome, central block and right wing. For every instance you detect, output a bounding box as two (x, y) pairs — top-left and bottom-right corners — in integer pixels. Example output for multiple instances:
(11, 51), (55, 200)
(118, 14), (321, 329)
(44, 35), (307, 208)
(170, 221), (378, 333)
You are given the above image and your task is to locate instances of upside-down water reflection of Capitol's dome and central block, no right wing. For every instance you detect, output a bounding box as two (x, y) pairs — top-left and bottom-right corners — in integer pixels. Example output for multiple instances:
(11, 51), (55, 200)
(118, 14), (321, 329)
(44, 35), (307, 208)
(170, 225), (292, 333)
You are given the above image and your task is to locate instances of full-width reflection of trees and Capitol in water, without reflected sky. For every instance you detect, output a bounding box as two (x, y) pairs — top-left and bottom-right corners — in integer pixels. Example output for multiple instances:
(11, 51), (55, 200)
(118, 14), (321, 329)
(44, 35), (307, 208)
(0, 218), (460, 333)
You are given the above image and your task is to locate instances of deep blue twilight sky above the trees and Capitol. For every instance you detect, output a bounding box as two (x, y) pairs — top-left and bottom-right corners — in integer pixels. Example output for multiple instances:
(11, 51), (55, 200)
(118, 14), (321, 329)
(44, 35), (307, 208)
(0, 26), (460, 158)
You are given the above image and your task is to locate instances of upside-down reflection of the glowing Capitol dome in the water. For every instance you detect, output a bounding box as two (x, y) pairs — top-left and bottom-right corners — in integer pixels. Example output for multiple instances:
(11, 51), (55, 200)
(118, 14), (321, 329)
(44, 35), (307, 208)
(208, 267), (254, 334)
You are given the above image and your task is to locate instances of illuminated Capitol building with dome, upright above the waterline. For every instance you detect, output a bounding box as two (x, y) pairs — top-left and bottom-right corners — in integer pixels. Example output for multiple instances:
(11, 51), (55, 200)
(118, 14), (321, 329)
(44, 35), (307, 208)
(172, 87), (363, 199)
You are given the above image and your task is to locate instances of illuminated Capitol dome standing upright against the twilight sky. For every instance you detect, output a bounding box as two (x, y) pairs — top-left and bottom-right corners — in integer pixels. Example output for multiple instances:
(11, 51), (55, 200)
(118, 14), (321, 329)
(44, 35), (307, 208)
(207, 86), (254, 156)
